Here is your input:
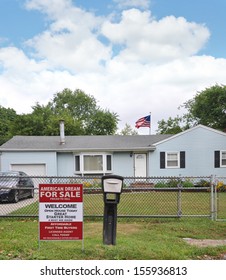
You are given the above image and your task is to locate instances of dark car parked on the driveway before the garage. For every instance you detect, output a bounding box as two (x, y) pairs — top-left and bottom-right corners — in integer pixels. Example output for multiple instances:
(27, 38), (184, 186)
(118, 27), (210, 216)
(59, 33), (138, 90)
(0, 171), (34, 202)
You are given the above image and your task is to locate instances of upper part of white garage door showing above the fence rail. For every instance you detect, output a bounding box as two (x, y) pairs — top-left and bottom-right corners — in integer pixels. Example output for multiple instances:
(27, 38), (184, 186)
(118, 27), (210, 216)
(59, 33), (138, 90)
(11, 164), (46, 176)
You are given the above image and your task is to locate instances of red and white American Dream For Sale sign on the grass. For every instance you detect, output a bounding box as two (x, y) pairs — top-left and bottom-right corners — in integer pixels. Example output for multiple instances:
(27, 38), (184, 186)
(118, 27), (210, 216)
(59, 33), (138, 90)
(39, 184), (83, 240)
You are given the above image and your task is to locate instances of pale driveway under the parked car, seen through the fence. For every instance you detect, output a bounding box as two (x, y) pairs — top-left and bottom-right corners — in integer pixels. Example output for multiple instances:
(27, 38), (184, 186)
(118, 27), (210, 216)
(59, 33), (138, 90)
(0, 193), (38, 216)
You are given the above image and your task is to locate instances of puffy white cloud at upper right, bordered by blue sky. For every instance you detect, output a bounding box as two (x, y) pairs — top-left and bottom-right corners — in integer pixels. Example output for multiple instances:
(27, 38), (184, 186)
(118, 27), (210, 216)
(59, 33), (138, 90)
(102, 9), (210, 63)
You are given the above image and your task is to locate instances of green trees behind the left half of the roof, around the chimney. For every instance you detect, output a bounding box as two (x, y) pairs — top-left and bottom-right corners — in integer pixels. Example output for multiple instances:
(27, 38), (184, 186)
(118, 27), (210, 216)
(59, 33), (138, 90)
(0, 89), (118, 144)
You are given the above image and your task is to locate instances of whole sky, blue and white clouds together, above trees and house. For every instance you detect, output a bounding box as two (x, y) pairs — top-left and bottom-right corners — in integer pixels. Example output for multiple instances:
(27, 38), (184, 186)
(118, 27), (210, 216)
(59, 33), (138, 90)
(0, 0), (226, 133)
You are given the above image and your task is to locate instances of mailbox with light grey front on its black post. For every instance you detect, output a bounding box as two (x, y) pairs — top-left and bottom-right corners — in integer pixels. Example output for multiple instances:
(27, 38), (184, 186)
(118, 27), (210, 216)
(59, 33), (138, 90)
(102, 175), (123, 245)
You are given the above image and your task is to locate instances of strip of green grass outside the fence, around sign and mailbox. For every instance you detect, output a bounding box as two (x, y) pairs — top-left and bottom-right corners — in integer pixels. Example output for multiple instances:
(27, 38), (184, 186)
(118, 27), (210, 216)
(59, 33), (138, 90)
(0, 218), (226, 260)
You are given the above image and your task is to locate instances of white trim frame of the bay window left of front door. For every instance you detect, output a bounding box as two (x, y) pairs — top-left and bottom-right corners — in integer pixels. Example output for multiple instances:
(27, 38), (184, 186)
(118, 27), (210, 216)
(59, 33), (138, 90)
(74, 153), (113, 174)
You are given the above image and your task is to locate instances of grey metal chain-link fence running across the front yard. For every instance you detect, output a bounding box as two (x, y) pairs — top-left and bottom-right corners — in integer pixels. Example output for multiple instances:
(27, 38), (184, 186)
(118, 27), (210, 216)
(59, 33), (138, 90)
(0, 176), (218, 219)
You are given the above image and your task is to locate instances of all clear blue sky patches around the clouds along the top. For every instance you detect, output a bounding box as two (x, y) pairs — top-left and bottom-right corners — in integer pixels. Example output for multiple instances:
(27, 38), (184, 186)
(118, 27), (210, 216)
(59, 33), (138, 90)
(0, 0), (226, 57)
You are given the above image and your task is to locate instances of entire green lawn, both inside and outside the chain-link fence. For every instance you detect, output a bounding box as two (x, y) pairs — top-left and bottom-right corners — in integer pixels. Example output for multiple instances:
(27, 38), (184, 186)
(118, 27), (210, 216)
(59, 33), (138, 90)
(0, 191), (226, 260)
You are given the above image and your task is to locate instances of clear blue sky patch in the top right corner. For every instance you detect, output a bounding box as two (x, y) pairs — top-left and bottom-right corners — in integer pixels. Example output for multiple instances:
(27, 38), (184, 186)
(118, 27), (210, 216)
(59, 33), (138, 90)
(152, 0), (226, 57)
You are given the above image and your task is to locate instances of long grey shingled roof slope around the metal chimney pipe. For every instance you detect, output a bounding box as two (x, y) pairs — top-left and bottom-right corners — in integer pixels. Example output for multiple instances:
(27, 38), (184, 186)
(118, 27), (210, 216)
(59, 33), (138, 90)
(0, 134), (172, 152)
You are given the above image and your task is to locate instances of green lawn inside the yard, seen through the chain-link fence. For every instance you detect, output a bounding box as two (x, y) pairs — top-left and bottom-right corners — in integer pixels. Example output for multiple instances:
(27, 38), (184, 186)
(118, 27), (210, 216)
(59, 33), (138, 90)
(8, 191), (219, 217)
